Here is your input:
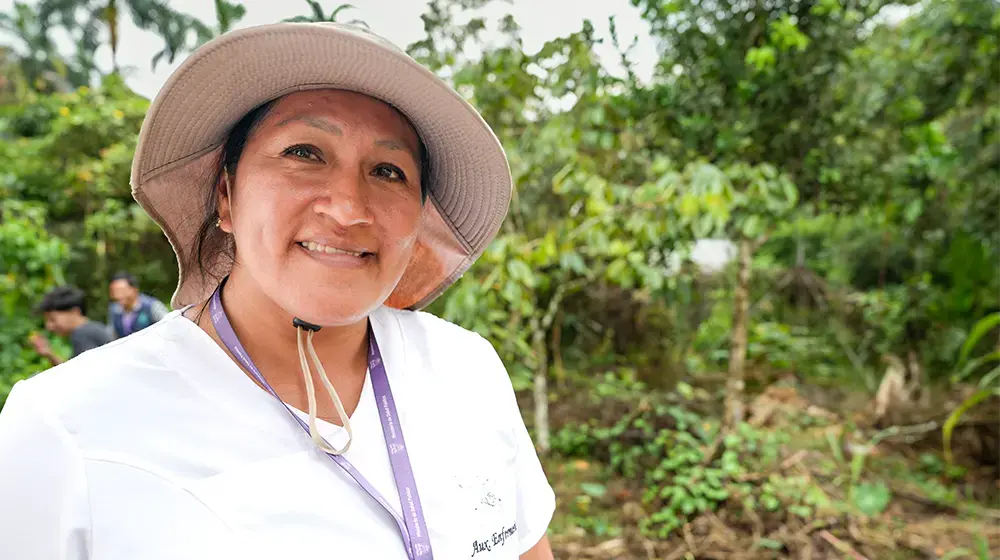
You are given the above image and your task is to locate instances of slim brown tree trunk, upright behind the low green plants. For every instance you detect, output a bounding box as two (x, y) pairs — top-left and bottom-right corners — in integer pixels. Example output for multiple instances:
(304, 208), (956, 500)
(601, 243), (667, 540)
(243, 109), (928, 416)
(725, 238), (753, 427)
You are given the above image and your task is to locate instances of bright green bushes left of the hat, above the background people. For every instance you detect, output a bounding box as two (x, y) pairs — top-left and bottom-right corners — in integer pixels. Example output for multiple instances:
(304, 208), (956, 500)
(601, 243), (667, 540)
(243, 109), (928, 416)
(0, 76), (176, 399)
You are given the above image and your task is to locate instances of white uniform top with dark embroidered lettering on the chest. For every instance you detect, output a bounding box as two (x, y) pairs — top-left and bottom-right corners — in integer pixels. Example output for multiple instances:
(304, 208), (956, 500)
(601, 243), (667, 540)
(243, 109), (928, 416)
(0, 308), (555, 560)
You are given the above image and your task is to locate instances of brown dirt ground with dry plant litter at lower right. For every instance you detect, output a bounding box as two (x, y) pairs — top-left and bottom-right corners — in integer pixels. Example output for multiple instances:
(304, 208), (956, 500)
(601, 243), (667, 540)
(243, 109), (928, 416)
(545, 382), (1000, 560)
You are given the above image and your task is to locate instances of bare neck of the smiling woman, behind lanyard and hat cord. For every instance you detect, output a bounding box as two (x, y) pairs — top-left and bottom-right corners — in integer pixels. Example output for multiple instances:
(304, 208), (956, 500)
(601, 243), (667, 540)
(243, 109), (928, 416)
(192, 267), (368, 423)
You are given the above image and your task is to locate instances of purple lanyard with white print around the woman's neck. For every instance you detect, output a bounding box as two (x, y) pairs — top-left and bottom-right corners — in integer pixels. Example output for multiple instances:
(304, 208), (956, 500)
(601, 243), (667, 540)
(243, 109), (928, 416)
(209, 285), (434, 560)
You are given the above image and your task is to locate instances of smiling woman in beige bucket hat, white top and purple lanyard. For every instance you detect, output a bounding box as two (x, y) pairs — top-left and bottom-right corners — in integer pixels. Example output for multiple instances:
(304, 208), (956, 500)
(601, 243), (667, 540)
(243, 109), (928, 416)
(0, 24), (554, 560)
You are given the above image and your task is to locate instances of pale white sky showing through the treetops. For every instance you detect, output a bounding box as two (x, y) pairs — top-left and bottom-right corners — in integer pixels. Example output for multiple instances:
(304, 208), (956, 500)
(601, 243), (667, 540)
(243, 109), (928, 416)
(0, 0), (657, 98)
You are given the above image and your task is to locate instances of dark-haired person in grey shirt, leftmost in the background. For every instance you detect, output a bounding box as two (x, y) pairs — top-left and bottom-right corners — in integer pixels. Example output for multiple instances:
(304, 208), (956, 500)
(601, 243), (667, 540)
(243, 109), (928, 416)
(31, 286), (111, 366)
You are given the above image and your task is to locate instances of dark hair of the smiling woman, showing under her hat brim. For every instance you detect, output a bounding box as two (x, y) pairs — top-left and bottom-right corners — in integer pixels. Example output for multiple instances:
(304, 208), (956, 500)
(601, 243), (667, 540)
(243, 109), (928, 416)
(193, 99), (431, 288)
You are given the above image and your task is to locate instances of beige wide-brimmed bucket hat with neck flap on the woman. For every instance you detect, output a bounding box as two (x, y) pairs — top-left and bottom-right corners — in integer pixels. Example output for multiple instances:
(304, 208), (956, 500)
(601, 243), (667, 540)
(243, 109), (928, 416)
(131, 23), (512, 309)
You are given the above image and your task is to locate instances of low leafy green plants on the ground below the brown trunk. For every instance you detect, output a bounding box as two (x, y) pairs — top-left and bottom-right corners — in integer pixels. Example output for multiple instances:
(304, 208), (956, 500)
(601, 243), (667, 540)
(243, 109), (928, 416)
(552, 403), (844, 538)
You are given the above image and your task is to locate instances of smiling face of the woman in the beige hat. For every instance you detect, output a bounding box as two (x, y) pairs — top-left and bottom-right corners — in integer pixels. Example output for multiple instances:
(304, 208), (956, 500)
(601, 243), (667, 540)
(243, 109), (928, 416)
(219, 90), (423, 326)
